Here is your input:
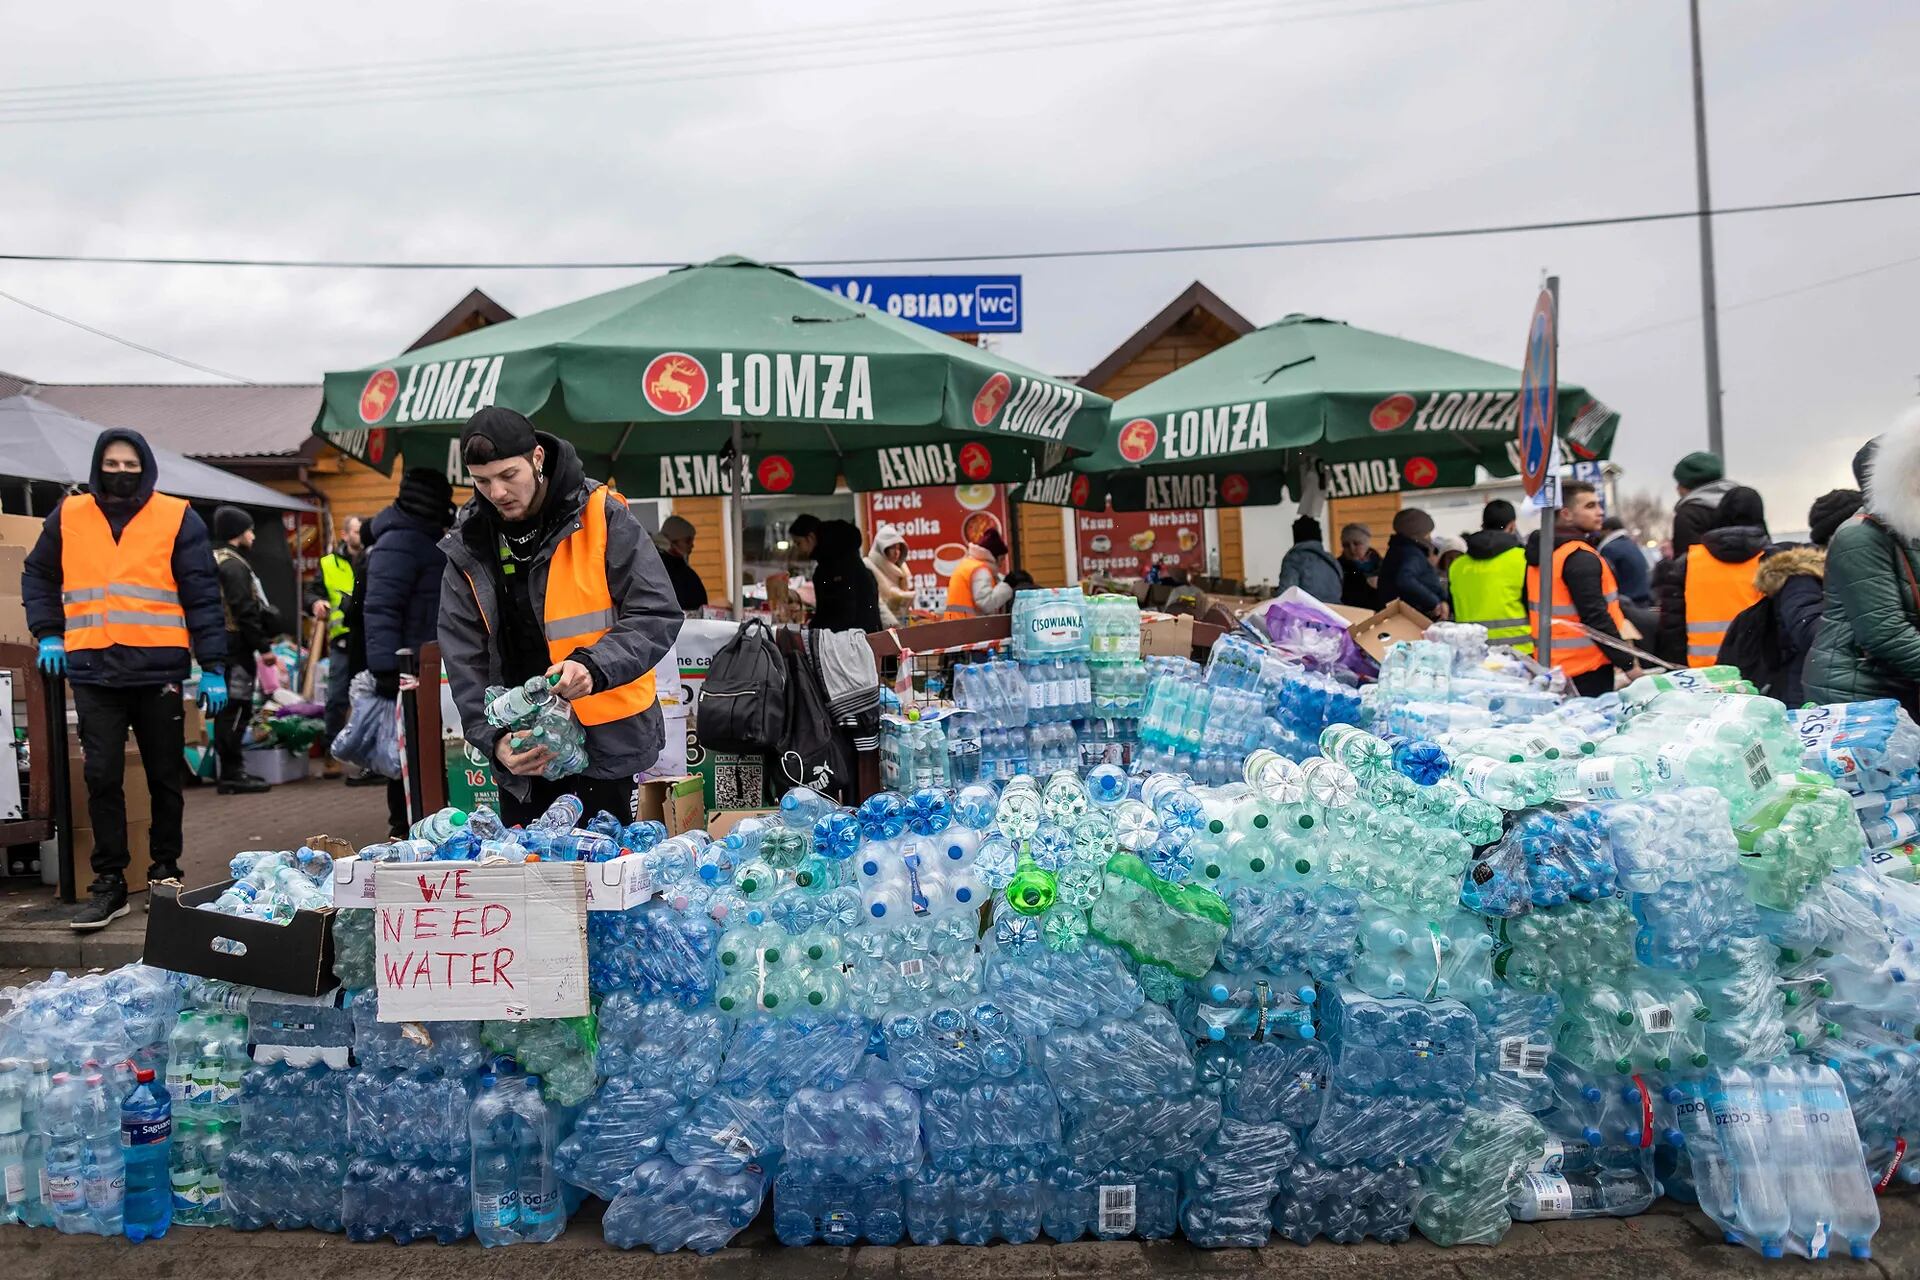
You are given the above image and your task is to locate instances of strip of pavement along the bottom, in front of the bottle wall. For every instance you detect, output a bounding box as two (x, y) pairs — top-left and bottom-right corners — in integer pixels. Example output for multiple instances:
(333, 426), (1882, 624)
(0, 1192), (1920, 1280)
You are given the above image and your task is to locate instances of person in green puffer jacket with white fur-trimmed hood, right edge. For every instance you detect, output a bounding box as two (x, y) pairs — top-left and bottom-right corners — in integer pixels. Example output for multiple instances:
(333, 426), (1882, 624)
(1805, 420), (1920, 714)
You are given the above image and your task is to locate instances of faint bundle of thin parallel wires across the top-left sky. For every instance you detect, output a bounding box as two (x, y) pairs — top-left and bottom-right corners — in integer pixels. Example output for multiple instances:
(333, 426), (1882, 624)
(0, 0), (1486, 125)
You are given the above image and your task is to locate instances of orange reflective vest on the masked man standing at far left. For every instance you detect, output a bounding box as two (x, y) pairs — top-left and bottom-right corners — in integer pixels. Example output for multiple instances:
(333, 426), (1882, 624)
(60, 493), (192, 651)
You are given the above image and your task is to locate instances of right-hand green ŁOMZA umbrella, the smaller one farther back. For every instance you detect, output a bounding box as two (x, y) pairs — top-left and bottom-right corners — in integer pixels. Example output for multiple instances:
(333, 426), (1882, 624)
(1060, 315), (1620, 507)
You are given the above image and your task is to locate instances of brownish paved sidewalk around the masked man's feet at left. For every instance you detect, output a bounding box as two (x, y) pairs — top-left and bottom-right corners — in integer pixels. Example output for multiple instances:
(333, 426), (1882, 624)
(0, 777), (386, 971)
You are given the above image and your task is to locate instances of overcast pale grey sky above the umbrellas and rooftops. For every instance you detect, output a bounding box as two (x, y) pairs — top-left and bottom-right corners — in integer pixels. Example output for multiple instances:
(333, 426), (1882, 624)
(0, 0), (1920, 528)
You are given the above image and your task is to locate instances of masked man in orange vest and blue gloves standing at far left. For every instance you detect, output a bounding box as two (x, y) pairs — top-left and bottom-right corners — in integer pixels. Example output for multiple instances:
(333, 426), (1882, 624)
(19, 428), (227, 931)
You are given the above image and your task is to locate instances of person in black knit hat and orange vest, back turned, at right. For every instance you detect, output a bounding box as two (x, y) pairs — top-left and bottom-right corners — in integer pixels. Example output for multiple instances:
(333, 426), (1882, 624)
(1653, 486), (1772, 666)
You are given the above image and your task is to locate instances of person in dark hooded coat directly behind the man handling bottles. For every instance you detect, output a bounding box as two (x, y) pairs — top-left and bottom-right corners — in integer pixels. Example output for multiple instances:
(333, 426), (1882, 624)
(359, 466), (453, 839)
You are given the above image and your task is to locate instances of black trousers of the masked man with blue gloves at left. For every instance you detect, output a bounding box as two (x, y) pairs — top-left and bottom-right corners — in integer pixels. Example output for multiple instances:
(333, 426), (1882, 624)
(69, 685), (186, 879)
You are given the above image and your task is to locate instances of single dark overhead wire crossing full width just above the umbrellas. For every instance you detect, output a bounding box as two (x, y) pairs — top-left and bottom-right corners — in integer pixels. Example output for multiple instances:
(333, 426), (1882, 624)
(0, 190), (1920, 271)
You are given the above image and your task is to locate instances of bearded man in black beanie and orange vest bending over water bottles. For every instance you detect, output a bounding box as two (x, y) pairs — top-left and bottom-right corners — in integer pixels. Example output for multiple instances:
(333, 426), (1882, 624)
(440, 407), (685, 825)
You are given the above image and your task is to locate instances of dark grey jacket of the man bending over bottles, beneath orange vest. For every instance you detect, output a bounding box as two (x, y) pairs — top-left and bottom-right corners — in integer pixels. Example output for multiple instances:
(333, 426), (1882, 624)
(440, 432), (685, 798)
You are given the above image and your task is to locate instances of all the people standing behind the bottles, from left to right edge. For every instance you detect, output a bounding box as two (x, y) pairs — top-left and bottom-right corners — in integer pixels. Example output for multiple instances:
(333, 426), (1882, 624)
(21, 395), (1920, 929)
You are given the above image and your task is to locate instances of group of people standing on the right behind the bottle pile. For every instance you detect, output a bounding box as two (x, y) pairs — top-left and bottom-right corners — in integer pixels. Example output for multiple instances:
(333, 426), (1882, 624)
(1279, 415), (1920, 714)
